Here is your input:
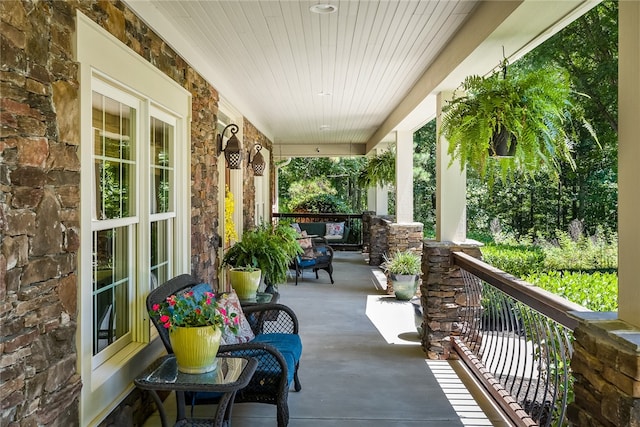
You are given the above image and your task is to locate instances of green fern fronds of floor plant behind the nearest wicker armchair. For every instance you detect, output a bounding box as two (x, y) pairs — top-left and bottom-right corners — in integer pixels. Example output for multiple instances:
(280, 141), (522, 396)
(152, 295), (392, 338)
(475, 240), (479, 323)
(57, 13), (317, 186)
(222, 224), (302, 298)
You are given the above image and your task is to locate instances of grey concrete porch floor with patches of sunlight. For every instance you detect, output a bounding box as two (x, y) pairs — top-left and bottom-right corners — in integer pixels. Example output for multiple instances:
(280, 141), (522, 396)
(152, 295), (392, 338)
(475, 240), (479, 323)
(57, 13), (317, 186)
(145, 252), (509, 427)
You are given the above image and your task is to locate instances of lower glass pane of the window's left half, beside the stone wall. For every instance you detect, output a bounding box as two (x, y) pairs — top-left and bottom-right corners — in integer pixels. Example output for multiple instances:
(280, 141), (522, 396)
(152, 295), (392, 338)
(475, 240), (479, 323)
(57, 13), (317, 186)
(93, 227), (131, 355)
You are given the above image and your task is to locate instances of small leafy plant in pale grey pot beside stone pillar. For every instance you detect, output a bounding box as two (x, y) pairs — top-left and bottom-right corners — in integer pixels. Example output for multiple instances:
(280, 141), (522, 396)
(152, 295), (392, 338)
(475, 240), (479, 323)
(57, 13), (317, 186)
(381, 250), (422, 301)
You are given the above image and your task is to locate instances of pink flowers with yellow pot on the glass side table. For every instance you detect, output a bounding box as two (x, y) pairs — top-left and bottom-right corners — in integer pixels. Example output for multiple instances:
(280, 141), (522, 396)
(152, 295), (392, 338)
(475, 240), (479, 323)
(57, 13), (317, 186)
(149, 285), (239, 374)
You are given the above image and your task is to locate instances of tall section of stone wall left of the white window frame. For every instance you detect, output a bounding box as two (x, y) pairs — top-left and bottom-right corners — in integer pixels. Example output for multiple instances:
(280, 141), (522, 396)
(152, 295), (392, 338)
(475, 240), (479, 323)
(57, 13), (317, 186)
(0, 1), (81, 426)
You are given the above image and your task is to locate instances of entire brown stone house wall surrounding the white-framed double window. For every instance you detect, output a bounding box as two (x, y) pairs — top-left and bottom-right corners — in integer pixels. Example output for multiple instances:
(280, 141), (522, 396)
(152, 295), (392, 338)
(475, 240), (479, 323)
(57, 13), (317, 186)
(0, 0), (269, 427)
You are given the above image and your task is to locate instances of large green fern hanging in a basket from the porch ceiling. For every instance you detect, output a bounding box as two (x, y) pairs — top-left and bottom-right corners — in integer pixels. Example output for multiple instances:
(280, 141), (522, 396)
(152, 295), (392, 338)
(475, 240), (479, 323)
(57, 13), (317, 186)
(440, 60), (595, 181)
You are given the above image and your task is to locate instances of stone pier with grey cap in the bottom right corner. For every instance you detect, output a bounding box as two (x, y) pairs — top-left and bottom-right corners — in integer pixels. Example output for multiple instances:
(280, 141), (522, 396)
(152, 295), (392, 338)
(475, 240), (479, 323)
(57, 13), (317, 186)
(568, 312), (640, 427)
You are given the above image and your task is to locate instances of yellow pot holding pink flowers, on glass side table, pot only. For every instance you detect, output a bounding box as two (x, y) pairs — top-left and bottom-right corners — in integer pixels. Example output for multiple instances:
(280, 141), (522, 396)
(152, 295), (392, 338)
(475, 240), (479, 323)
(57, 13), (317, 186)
(169, 326), (222, 374)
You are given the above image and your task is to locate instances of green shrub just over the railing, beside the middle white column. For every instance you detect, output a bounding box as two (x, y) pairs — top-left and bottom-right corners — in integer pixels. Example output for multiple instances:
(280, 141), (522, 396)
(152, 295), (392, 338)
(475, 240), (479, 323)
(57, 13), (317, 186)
(481, 245), (544, 277)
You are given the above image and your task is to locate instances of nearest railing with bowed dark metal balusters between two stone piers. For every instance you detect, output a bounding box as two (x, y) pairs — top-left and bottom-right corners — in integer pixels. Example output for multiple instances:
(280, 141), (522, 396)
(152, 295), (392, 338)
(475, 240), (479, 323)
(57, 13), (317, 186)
(452, 252), (589, 426)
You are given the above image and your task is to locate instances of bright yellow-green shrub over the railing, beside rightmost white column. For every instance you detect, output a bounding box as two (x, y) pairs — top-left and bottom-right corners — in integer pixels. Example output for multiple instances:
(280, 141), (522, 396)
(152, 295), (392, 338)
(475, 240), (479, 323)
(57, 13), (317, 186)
(524, 271), (618, 311)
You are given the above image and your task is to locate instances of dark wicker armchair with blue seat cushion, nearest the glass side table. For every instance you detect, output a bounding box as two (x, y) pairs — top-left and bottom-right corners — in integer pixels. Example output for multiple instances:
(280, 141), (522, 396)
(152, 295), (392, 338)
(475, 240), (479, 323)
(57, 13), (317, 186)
(147, 274), (302, 427)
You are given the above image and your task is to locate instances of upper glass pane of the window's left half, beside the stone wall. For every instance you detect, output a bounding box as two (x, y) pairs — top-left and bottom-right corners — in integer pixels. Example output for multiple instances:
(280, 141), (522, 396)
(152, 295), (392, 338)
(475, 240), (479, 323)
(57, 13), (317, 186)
(92, 92), (136, 219)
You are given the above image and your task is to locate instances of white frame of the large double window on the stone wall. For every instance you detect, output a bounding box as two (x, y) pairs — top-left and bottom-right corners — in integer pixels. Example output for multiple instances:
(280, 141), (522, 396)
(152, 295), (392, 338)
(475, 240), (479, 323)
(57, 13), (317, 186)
(76, 12), (191, 426)
